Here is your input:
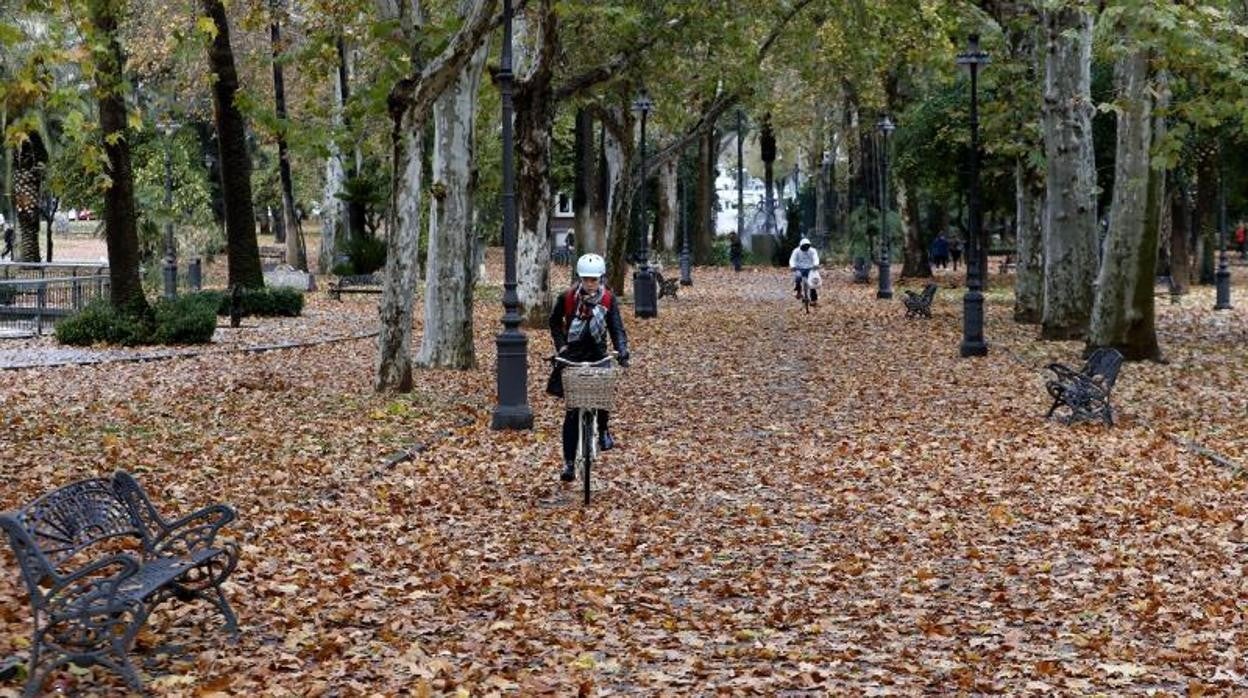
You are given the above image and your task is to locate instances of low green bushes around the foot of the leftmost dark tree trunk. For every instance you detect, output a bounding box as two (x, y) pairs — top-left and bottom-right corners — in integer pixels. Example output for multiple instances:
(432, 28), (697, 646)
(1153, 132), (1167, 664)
(56, 293), (217, 346)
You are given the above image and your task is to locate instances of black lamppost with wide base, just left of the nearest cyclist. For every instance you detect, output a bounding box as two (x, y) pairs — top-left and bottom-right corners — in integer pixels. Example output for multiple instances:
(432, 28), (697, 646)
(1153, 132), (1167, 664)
(490, 0), (533, 430)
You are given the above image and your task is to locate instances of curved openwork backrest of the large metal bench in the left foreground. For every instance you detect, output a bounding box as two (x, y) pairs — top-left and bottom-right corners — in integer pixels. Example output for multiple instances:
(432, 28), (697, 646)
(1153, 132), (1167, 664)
(0, 478), (146, 598)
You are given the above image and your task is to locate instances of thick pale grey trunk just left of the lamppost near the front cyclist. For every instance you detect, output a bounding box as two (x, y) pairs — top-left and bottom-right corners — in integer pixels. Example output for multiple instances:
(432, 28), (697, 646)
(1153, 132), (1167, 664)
(416, 44), (484, 368)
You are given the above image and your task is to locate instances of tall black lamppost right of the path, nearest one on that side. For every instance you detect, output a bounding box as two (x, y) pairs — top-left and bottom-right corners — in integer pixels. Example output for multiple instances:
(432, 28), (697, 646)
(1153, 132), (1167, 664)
(957, 34), (988, 357)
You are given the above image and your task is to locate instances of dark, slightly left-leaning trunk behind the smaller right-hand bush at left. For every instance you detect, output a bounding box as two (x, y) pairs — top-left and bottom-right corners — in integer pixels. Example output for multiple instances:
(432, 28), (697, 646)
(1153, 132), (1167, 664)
(201, 0), (265, 288)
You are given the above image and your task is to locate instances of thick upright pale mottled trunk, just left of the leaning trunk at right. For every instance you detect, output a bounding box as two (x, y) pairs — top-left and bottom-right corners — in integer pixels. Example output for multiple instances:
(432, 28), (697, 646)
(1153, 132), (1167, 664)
(1041, 7), (1097, 340)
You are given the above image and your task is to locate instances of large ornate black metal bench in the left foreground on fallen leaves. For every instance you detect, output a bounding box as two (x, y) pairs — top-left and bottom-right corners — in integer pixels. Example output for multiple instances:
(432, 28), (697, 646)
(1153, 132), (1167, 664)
(0, 471), (238, 697)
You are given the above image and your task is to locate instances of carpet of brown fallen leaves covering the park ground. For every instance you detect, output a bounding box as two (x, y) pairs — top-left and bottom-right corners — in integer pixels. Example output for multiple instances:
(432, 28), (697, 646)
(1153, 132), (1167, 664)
(0, 260), (1248, 697)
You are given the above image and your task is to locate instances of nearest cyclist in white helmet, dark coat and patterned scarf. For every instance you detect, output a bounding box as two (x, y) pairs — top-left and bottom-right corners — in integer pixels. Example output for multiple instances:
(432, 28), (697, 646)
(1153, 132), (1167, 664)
(547, 253), (629, 482)
